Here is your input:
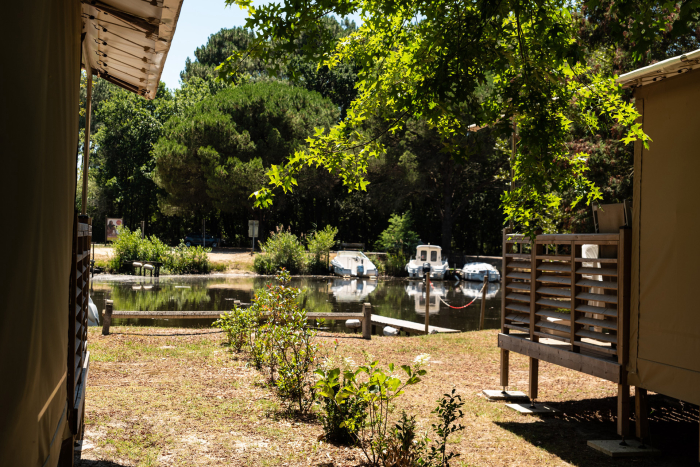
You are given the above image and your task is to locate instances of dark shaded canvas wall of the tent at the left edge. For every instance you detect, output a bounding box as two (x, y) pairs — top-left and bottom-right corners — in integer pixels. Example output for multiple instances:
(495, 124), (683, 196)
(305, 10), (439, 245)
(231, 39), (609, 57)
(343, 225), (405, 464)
(0, 0), (81, 466)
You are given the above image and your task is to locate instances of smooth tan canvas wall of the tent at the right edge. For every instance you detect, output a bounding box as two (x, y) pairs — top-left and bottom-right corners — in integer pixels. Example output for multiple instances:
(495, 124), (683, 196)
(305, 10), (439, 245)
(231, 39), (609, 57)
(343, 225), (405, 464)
(630, 70), (700, 404)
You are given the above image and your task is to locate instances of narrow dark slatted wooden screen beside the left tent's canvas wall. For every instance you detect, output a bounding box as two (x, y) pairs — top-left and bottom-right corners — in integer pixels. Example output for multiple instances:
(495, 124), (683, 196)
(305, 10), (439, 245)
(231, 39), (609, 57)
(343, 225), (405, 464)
(67, 213), (92, 435)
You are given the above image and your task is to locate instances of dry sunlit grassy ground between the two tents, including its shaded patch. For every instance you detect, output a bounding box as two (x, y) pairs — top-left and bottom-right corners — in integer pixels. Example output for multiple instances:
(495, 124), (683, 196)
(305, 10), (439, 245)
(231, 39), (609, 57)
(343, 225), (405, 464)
(77, 327), (698, 467)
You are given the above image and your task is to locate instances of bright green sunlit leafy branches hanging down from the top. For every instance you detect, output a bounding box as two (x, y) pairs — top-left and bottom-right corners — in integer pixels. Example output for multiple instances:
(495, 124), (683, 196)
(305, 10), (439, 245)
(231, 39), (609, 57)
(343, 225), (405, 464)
(219, 0), (646, 234)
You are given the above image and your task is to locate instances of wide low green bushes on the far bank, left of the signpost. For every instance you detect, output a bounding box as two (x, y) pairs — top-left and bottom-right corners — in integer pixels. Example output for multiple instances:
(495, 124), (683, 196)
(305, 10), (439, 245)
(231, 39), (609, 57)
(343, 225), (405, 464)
(109, 227), (211, 274)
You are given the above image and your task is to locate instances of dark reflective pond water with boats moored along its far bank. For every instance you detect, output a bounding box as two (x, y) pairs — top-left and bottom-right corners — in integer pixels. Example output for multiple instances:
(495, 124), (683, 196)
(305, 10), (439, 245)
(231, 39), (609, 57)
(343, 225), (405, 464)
(91, 275), (501, 331)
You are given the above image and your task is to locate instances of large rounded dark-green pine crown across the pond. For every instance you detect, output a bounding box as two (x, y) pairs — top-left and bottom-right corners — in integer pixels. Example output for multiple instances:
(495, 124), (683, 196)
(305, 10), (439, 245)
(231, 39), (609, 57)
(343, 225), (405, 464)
(153, 82), (338, 218)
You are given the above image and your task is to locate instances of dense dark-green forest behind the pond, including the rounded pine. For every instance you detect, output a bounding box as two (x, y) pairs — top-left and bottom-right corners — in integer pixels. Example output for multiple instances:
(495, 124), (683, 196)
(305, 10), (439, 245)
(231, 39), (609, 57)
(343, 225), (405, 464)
(76, 6), (700, 255)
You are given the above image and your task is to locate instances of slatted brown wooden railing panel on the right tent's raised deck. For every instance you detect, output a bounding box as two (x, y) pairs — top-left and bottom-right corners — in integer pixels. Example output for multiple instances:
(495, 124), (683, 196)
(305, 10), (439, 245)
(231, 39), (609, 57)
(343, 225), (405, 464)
(501, 229), (631, 364)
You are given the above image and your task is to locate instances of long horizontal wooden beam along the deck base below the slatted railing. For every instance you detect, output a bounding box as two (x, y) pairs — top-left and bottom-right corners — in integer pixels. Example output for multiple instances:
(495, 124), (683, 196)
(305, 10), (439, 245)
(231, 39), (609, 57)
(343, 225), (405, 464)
(498, 334), (621, 383)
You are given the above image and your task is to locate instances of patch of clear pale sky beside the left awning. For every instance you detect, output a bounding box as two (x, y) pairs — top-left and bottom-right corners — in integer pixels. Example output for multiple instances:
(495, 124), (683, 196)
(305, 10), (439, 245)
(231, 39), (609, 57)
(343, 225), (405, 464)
(160, 0), (360, 89)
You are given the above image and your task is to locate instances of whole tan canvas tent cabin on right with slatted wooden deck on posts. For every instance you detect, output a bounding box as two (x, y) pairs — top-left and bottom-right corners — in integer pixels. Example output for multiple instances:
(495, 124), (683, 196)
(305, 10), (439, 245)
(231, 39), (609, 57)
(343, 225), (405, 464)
(498, 50), (700, 460)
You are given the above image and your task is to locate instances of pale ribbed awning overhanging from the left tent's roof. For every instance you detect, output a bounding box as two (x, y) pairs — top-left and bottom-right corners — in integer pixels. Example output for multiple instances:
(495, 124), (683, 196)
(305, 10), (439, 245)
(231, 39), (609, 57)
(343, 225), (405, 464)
(82, 0), (183, 99)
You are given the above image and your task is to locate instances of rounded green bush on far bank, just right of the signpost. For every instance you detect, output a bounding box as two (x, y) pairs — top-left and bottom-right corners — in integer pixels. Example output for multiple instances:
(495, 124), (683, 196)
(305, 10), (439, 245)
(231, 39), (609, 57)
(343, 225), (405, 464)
(253, 228), (306, 274)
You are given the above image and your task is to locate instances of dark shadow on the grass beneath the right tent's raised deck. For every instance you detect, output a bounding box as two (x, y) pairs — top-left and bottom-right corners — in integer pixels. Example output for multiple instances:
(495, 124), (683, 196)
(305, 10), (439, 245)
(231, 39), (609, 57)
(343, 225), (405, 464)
(495, 395), (698, 467)
